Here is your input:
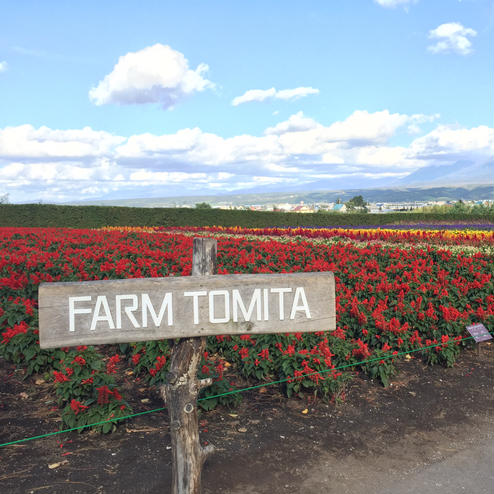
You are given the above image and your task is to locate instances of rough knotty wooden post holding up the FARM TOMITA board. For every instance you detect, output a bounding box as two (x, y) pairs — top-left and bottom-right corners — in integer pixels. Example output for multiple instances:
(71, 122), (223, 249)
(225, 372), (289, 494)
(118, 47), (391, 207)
(161, 238), (217, 494)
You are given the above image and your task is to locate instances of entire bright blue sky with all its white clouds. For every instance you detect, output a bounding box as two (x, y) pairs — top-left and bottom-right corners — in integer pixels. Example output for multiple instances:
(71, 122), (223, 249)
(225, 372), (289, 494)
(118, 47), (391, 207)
(0, 0), (494, 202)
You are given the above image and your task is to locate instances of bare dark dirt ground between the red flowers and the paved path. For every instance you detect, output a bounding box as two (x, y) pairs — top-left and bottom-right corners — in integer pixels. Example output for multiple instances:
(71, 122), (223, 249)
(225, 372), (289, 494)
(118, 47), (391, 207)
(0, 343), (494, 494)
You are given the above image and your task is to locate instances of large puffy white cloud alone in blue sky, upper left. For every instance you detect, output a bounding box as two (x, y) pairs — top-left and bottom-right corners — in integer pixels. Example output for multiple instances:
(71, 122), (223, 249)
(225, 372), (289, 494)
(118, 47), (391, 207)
(89, 43), (214, 109)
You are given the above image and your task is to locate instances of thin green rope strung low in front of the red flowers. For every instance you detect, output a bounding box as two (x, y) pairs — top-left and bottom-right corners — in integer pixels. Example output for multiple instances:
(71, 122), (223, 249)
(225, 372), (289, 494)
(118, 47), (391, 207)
(0, 331), (492, 448)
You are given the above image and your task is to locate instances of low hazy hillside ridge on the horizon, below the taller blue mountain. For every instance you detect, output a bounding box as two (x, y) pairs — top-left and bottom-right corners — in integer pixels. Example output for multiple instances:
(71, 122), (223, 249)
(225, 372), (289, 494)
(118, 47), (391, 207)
(69, 183), (494, 207)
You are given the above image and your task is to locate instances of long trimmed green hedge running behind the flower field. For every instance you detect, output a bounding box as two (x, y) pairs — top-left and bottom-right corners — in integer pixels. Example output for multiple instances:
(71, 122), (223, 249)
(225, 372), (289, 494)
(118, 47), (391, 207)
(0, 204), (494, 228)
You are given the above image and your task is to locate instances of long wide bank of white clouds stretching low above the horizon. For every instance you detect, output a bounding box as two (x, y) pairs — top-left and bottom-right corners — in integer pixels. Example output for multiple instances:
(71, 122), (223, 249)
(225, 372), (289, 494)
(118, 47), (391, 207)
(0, 114), (494, 202)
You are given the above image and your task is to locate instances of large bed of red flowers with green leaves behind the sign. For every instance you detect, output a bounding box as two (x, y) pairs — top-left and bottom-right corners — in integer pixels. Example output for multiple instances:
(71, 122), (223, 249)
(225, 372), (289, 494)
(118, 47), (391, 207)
(0, 228), (494, 432)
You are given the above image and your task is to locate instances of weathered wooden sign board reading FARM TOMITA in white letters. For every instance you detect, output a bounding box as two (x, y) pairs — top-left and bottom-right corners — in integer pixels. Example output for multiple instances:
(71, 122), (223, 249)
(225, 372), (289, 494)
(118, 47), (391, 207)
(39, 272), (336, 348)
